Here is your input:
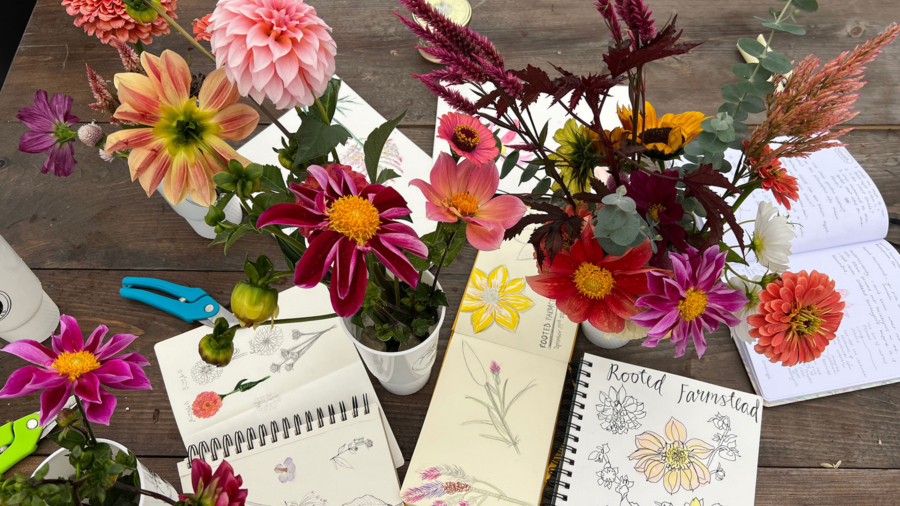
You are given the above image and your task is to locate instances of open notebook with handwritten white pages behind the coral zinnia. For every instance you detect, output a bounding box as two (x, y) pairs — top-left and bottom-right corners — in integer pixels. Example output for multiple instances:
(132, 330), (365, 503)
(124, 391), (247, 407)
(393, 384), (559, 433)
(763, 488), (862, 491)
(729, 147), (900, 406)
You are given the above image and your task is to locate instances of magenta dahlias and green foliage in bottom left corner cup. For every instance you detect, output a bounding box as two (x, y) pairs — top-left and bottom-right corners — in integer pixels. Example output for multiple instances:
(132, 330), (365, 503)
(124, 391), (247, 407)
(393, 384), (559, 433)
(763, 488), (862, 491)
(0, 315), (247, 506)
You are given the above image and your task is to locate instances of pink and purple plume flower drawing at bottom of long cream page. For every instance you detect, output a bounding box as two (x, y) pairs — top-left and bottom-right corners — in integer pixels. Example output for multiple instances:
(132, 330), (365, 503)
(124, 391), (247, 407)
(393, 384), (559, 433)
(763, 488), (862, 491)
(400, 465), (534, 506)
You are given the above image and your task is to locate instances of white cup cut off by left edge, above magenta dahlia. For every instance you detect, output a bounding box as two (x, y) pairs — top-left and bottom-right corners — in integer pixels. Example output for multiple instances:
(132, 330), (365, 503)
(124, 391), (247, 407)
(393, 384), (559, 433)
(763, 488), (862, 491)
(0, 236), (59, 342)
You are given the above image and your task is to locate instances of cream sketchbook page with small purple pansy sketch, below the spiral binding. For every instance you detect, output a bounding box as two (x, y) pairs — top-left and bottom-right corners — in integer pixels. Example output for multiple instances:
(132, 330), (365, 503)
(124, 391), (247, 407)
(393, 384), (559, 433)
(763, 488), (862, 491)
(178, 413), (402, 506)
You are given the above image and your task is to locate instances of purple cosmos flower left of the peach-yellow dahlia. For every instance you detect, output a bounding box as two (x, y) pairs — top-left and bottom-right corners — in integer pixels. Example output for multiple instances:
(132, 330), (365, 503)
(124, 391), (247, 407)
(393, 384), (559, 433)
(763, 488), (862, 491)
(16, 90), (78, 177)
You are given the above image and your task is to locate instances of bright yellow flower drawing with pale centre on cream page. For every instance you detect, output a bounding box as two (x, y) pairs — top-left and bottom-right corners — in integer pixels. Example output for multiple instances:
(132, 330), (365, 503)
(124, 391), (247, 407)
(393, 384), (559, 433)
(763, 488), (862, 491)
(459, 265), (534, 333)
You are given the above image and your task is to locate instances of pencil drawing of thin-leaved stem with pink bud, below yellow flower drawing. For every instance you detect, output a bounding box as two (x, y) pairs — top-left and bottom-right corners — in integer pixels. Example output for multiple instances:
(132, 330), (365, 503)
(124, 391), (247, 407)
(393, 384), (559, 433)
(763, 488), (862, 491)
(463, 342), (537, 453)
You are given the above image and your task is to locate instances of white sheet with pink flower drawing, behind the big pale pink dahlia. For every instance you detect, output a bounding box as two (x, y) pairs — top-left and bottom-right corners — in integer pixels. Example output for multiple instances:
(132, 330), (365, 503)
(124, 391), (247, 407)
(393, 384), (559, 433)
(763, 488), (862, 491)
(238, 77), (437, 236)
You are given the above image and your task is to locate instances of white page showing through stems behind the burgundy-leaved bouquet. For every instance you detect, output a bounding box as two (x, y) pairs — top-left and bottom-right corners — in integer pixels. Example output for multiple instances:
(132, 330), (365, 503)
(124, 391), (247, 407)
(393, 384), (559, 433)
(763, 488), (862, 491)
(431, 84), (629, 193)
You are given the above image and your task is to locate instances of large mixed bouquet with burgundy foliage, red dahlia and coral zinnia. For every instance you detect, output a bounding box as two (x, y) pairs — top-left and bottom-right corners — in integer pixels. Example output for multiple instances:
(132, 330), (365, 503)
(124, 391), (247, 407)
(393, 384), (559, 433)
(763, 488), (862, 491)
(398, 0), (900, 366)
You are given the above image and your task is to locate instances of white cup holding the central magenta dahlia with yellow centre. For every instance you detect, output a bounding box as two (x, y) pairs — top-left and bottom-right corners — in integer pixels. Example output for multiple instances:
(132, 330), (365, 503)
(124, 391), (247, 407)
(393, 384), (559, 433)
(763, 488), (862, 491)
(339, 271), (447, 395)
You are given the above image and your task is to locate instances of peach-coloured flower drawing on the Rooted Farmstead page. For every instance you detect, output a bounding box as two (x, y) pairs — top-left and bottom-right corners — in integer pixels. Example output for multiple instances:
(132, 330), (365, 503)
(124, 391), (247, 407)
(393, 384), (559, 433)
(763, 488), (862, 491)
(628, 417), (714, 494)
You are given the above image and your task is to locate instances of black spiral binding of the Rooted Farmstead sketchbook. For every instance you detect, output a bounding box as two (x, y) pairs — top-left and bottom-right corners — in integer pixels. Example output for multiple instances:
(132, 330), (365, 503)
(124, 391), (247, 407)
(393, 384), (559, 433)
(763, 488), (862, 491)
(541, 358), (593, 506)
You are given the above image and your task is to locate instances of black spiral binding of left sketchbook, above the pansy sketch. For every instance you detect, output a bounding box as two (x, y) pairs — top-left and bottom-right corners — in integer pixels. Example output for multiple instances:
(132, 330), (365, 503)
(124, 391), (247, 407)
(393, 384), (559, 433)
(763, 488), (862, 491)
(187, 394), (371, 468)
